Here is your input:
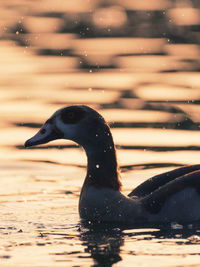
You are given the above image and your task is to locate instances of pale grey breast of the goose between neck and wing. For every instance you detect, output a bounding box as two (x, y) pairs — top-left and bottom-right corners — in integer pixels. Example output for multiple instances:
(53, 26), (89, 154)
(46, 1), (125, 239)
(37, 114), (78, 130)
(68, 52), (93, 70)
(79, 186), (142, 223)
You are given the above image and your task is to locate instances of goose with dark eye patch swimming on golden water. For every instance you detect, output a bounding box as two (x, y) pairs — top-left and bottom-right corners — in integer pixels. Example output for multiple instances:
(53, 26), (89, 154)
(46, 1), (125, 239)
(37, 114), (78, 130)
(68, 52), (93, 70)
(25, 105), (200, 224)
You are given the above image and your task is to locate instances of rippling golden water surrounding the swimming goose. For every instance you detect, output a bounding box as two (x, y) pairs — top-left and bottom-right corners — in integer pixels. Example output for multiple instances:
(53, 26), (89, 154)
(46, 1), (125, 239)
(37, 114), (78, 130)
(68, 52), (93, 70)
(0, 0), (200, 267)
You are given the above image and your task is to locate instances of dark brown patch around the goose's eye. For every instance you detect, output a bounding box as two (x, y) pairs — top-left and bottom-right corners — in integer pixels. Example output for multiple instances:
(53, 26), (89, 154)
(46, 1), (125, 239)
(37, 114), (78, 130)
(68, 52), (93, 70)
(61, 106), (86, 124)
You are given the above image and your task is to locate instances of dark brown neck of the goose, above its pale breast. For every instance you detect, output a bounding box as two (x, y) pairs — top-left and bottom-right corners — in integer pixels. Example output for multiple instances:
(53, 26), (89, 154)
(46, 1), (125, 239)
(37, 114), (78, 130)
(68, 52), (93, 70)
(81, 128), (121, 191)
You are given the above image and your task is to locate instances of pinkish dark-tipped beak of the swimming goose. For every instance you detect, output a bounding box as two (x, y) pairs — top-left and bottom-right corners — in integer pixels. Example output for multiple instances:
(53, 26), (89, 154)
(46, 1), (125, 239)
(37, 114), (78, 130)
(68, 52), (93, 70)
(24, 121), (63, 147)
